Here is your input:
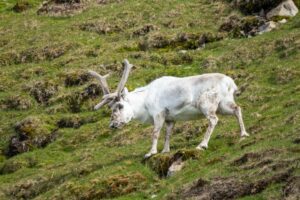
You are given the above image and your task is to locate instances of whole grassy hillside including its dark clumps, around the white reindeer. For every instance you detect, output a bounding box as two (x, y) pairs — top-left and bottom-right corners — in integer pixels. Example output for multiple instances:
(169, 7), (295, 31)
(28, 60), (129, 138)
(0, 0), (300, 199)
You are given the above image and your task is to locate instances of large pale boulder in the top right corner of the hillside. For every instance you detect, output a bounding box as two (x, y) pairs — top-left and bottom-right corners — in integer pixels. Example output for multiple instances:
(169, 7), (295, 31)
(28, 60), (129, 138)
(267, 0), (299, 19)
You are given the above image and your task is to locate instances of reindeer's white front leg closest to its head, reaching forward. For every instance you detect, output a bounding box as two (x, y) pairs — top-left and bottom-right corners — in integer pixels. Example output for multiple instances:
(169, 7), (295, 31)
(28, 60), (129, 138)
(145, 113), (165, 158)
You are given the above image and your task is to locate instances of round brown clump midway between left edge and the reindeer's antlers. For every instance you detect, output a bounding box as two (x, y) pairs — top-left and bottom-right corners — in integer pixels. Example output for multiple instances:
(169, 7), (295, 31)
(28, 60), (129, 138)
(29, 81), (58, 104)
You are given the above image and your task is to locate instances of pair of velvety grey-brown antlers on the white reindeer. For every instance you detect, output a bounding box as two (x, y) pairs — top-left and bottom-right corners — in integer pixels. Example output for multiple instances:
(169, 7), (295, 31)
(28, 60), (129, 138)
(88, 59), (133, 110)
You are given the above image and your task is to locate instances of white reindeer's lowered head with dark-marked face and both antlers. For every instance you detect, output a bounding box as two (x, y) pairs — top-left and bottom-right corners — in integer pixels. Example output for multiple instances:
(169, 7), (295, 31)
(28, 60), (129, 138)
(89, 59), (133, 128)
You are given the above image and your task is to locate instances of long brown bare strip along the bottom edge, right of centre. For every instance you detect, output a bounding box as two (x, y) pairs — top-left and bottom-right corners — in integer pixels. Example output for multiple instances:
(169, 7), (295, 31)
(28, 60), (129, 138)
(176, 170), (292, 200)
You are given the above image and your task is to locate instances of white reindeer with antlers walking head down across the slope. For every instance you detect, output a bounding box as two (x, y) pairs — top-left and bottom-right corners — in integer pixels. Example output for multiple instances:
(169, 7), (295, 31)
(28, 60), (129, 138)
(89, 59), (249, 158)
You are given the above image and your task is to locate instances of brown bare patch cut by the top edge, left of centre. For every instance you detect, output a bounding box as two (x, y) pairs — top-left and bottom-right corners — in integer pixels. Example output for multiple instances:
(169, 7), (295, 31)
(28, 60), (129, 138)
(37, 0), (88, 16)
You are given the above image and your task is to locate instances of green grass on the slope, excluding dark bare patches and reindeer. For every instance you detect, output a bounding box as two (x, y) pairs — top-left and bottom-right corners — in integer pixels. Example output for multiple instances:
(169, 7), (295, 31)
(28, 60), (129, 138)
(0, 0), (300, 199)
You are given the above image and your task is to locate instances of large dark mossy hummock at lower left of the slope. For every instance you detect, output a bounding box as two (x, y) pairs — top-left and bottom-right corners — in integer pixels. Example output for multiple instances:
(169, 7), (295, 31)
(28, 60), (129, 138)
(5, 117), (57, 157)
